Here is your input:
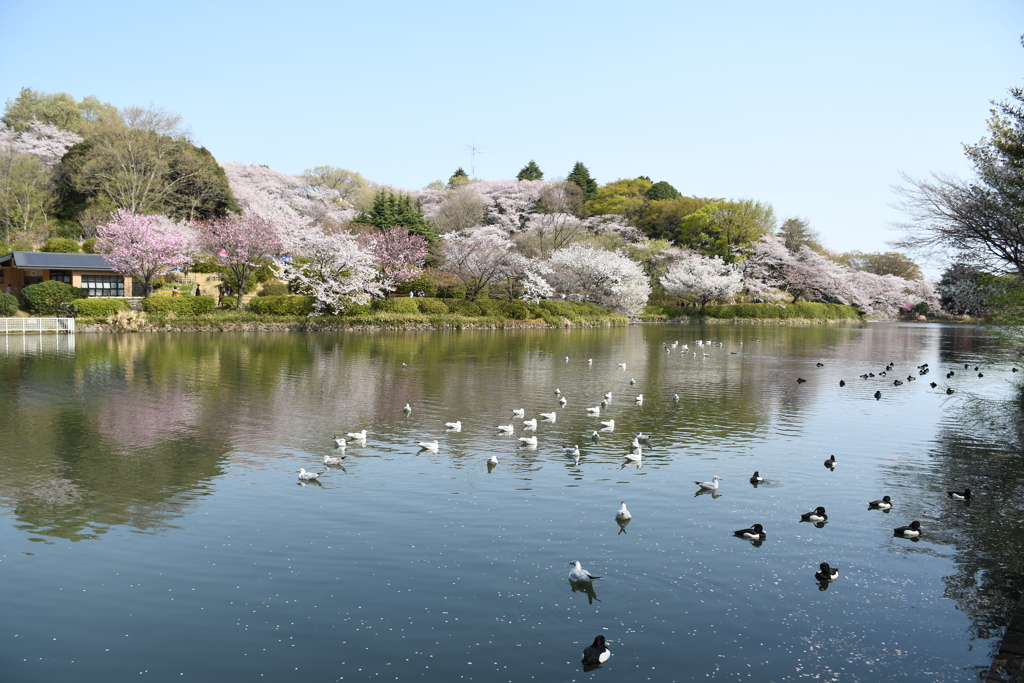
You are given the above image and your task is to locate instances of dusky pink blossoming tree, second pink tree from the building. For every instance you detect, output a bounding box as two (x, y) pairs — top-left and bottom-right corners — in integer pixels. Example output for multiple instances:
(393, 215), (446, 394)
(198, 212), (282, 308)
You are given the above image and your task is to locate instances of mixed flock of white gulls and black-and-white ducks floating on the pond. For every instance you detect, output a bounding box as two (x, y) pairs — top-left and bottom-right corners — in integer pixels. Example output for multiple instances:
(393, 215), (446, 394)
(290, 340), (1018, 671)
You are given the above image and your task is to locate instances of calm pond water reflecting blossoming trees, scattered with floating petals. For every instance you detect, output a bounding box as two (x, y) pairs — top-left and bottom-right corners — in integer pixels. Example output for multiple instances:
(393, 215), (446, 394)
(0, 325), (1020, 683)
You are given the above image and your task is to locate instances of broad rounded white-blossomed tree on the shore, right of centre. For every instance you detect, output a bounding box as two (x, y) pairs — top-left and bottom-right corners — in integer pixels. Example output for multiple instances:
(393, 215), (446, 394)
(548, 244), (651, 317)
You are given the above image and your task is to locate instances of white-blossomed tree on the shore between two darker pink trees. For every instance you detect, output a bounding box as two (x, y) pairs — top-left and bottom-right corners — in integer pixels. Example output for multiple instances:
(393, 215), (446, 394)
(275, 230), (384, 315)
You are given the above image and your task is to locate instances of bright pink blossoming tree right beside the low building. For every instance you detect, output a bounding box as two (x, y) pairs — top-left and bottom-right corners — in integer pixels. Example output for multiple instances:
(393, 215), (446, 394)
(96, 209), (193, 296)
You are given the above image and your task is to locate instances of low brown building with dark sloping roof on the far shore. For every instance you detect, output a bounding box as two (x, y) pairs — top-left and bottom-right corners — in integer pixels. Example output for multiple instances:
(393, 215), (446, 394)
(0, 251), (131, 301)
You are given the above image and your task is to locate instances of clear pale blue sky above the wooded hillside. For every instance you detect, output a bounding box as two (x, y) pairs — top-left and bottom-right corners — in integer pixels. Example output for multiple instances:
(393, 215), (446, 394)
(0, 0), (1024, 272)
